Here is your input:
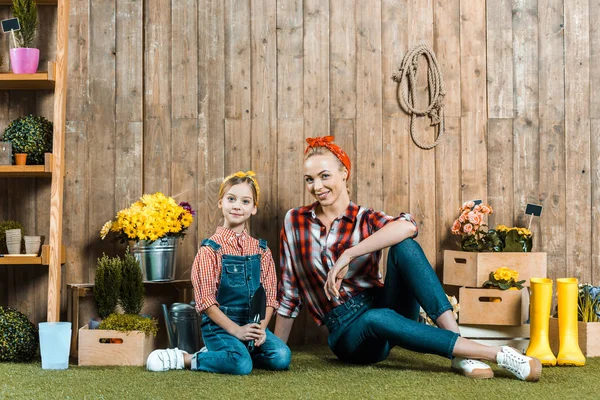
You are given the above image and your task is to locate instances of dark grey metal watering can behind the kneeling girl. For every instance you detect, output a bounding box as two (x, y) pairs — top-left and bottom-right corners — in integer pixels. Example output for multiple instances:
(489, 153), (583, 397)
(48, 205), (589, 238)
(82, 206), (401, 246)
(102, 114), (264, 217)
(162, 301), (200, 354)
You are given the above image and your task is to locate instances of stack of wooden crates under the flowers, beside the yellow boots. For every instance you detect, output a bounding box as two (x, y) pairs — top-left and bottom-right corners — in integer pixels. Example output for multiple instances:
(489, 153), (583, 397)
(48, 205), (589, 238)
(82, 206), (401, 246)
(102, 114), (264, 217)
(443, 250), (546, 351)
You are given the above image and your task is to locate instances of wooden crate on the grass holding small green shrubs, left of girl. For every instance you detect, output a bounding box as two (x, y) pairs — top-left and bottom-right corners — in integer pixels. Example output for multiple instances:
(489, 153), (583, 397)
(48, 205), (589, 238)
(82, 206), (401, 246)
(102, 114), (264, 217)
(78, 325), (155, 366)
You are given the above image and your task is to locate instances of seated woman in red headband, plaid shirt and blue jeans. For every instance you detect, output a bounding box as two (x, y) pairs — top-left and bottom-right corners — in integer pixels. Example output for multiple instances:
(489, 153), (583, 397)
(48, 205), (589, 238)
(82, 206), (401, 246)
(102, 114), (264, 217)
(275, 136), (542, 381)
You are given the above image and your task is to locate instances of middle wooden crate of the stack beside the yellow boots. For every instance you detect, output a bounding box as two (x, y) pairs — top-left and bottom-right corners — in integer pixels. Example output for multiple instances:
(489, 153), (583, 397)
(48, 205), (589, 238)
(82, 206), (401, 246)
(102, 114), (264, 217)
(458, 287), (529, 326)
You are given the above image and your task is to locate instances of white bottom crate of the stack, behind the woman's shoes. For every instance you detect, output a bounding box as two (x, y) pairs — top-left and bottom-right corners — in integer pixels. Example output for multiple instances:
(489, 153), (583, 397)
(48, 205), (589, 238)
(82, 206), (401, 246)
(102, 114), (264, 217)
(458, 324), (530, 353)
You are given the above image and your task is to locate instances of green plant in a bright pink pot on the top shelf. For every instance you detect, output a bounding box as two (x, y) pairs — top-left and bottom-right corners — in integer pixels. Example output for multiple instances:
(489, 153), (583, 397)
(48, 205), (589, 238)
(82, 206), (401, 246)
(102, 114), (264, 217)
(10, 0), (40, 74)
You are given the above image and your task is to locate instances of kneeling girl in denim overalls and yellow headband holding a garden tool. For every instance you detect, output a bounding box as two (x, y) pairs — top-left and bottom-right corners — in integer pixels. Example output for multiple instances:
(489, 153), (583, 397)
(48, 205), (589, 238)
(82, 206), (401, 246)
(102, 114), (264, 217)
(146, 171), (291, 375)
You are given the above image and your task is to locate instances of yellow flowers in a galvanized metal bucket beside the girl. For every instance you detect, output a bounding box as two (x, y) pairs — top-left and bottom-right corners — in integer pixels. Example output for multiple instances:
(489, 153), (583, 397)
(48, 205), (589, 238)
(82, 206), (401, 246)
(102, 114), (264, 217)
(100, 192), (195, 282)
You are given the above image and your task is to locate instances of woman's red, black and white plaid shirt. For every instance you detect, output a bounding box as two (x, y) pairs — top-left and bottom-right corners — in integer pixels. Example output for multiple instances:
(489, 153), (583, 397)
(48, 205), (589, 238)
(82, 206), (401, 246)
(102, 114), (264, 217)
(277, 202), (418, 325)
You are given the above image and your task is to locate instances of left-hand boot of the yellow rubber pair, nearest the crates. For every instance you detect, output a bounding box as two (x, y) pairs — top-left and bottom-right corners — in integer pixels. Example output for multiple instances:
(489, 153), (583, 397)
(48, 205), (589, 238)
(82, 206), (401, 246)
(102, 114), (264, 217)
(526, 278), (556, 366)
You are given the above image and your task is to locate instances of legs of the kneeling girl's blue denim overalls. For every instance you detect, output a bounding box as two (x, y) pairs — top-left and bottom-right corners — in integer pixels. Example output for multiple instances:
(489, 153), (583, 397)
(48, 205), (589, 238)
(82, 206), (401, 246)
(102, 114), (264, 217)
(192, 317), (292, 375)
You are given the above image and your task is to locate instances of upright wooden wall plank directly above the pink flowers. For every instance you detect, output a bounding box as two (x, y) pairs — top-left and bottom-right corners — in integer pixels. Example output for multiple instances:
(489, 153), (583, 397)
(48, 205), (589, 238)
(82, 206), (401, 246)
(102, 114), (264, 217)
(460, 0), (487, 201)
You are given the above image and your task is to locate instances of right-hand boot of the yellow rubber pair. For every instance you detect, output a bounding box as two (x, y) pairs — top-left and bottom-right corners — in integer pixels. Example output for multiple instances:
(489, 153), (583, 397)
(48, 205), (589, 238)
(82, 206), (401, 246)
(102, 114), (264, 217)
(556, 278), (585, 367)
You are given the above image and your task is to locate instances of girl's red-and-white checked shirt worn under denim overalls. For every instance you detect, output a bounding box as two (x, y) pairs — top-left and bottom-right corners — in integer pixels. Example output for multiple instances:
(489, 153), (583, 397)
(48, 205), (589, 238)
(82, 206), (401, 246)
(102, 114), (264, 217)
(192, 226), (279, 313)
